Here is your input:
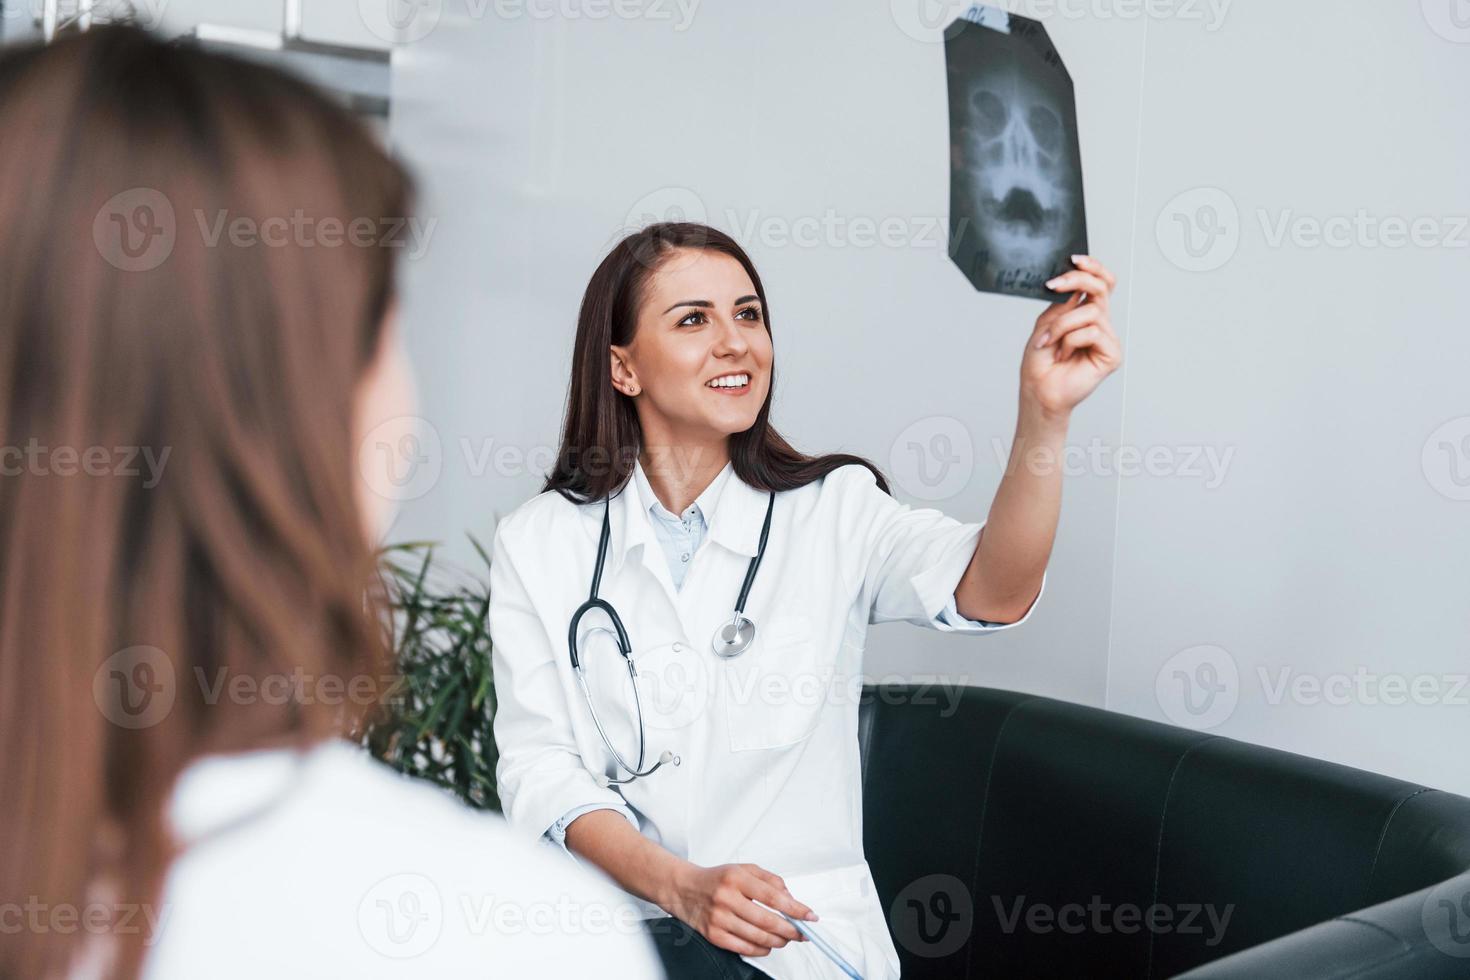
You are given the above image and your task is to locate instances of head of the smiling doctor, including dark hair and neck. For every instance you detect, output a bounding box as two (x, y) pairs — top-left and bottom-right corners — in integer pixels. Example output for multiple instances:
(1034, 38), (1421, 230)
(541, 222), (888, 513)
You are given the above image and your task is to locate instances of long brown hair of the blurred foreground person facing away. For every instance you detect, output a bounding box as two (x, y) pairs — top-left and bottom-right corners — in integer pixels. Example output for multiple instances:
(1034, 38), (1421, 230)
(0, 26), (410, 977)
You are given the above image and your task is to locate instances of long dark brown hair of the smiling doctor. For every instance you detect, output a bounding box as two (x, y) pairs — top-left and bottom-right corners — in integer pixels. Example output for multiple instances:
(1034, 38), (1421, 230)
(541, 222), (888, 504)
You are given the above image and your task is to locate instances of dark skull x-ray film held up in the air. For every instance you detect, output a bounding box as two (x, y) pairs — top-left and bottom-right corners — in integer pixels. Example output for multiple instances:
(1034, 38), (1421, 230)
(944, 6), (1088, 301)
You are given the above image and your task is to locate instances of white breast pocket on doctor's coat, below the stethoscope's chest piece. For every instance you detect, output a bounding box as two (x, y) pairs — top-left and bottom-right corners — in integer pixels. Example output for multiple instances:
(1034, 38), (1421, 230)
(717, 614), (832, 751)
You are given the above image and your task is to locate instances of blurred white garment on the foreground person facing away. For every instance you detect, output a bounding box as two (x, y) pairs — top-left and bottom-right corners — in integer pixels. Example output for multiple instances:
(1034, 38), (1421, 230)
(140, 741), (663, 980)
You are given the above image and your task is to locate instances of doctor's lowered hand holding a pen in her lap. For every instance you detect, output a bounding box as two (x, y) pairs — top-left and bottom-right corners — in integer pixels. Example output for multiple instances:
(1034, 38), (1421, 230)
(664, 862), (816, 956)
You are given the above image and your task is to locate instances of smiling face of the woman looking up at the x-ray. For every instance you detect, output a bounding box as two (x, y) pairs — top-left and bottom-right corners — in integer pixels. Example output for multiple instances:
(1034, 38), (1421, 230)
(612, 247), (773, 464)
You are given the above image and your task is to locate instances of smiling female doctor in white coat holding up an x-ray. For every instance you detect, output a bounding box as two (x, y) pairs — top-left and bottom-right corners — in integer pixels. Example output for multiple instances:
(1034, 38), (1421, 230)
(488, 223), (1122, 980)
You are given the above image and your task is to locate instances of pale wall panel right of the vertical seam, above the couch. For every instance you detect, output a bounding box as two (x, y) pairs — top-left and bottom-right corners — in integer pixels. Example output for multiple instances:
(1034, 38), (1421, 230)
(1107, 0), (1470, 793)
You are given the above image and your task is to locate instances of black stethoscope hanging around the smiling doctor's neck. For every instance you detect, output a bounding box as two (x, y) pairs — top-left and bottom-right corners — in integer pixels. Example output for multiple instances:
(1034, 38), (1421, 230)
(566, 491), (776, 786)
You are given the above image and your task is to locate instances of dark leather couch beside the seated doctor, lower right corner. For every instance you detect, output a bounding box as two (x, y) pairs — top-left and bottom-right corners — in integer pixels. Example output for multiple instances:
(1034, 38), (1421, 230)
(858, 685), (1470, 980)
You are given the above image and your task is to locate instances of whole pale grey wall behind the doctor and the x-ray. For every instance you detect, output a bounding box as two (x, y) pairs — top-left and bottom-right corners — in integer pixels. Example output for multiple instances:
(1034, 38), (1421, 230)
(392, 0), (1470, 792)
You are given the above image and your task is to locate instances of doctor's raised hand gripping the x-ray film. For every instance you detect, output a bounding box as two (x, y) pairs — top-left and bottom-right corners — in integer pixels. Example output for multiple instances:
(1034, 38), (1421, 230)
(1020, 256), (1123, 419)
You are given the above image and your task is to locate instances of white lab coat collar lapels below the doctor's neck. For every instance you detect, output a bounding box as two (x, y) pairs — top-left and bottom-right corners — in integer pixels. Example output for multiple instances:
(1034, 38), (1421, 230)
(607, 460), (767, 578)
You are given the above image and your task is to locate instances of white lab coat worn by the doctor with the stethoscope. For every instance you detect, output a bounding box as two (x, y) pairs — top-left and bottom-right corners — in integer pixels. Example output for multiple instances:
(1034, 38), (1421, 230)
(490, 463), (1045, 980)
